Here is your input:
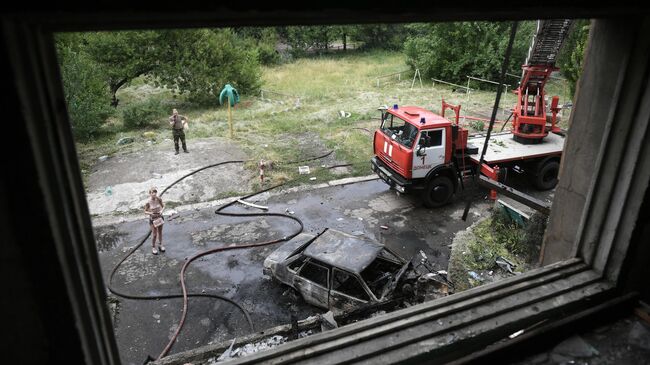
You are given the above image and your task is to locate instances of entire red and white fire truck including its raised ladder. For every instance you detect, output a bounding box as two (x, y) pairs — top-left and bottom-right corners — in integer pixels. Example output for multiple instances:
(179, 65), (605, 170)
(370, 19), (572, 208)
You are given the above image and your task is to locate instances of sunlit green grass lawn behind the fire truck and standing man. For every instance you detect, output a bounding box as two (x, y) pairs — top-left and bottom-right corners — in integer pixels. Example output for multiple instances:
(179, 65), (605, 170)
(77, 51), (568, 191)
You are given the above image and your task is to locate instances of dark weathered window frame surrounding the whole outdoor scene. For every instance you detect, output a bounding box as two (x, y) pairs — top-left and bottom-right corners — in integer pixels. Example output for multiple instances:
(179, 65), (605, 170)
(3, 9), (650, 364)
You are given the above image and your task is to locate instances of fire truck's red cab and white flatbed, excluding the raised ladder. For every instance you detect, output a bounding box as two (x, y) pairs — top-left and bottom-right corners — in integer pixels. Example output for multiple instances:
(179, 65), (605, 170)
(371, 101), (564, 207)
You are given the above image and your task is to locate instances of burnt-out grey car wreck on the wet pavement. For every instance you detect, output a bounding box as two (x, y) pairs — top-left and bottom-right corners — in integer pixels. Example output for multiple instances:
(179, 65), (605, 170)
(264, 229), (449, 313)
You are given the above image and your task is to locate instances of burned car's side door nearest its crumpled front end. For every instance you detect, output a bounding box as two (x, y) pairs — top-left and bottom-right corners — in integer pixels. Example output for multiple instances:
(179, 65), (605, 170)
(330, 268), (373, 312)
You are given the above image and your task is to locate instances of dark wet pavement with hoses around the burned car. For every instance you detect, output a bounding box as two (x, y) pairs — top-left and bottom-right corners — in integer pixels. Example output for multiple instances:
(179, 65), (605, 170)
(95, 176), (491, 365)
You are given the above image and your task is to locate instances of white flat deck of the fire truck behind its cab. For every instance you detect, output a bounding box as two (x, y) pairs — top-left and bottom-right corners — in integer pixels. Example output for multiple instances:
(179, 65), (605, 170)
(467, 133), (565, 164)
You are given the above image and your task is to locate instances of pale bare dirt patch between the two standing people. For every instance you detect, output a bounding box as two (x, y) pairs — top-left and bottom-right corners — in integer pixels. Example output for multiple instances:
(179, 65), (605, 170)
(86, 137), (252, 218)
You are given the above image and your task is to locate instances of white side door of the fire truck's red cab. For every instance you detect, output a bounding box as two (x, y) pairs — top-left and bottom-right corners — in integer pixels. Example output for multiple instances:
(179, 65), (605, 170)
(413, 128), (446, 179)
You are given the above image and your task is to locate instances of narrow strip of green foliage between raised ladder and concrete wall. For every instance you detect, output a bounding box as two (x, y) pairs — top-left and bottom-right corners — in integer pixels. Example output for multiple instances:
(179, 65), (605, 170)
(557, 19), (589, 95)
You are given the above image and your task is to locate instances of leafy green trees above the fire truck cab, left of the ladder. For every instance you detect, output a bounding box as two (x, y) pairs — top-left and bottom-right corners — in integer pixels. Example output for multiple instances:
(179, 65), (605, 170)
(404, 22), (535, 86)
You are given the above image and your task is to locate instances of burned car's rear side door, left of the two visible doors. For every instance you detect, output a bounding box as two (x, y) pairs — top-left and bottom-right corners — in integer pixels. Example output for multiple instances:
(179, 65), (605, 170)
(293, 260), (330, 309)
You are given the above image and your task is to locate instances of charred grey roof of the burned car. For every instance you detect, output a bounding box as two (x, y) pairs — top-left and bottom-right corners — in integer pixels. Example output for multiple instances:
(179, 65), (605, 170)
(304, 229), (384, 274)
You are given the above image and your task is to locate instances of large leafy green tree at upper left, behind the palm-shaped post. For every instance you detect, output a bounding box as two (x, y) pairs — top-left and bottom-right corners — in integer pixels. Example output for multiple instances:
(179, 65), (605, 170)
(74, 29), (261, 106)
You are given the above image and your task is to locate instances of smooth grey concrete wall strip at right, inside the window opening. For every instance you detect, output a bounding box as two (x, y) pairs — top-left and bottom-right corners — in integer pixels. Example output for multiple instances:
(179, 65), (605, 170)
(541, 20), (634, 265)
